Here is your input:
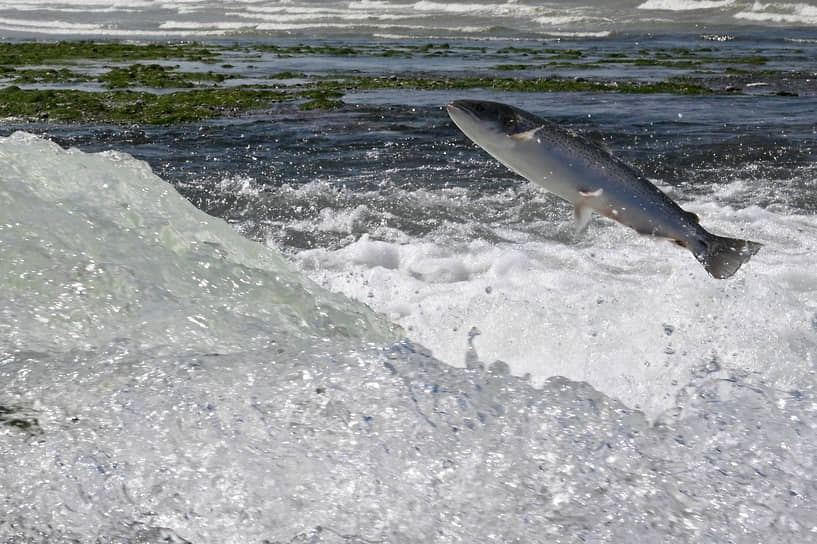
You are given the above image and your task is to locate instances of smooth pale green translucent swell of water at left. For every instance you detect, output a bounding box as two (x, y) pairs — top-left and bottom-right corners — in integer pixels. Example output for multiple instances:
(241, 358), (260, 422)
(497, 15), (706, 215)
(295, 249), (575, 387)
(0, 133), (396, 351)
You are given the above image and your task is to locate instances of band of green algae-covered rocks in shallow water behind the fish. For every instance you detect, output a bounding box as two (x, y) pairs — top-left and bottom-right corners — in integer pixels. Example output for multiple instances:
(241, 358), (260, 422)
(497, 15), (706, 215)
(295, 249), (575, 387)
(0, 41), (797, 124)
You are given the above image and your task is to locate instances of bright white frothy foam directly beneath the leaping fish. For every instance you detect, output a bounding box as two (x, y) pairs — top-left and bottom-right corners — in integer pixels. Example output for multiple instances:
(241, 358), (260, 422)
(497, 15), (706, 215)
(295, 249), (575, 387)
(297, 181), (817, 413)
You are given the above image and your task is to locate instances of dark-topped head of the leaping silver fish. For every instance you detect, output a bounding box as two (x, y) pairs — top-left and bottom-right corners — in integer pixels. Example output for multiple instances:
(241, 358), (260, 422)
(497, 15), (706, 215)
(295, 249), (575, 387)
(446, 100), (543, 144)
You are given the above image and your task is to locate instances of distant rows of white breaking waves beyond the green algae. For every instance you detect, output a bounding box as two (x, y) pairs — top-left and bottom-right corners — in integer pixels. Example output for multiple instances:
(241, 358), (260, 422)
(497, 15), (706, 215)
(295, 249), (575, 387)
(0, 0), (817, 39)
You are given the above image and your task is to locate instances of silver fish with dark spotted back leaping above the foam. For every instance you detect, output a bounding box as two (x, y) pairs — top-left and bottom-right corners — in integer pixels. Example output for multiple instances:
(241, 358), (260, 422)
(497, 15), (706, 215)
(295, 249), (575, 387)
(447, 100), (761, 278)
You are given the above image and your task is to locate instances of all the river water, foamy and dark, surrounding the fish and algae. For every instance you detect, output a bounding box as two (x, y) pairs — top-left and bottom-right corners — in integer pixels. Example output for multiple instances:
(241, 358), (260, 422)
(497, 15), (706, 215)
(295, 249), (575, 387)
(0, 0), (817, 543)
